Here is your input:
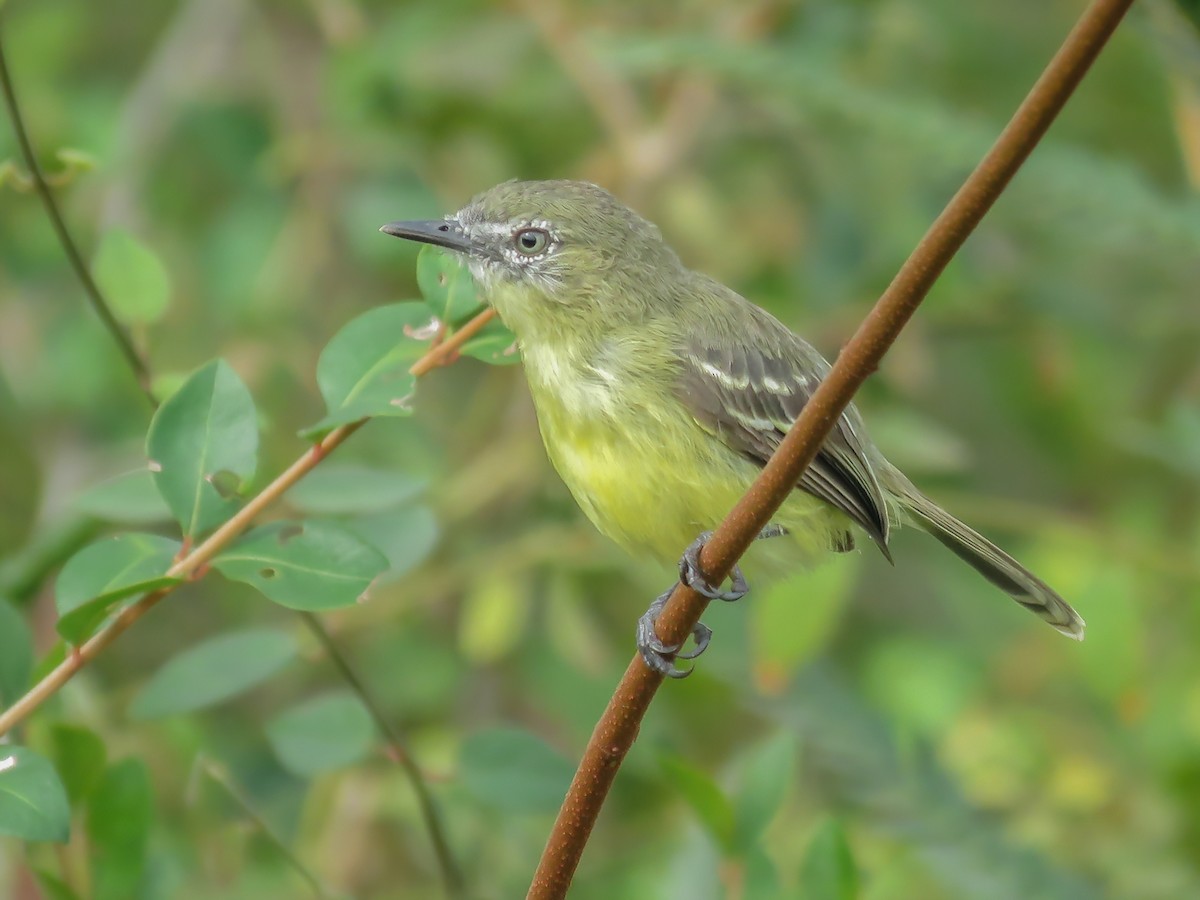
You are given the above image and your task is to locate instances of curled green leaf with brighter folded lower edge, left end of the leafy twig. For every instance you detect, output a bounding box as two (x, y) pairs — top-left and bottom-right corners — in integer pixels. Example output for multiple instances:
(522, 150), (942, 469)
(54, 533), (181, 644)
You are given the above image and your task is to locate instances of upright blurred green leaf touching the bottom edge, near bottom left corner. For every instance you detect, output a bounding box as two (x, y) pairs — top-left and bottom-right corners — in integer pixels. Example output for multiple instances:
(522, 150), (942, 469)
(88, 758), (154, 900)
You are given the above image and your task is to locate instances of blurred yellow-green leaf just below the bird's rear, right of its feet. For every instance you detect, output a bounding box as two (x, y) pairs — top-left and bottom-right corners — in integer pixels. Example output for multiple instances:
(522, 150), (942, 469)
(750, 553), (859, 690)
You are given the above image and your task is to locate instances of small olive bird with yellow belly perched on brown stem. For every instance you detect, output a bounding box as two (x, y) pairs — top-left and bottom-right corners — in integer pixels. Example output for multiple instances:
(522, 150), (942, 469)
(380, 181), (1084, 677)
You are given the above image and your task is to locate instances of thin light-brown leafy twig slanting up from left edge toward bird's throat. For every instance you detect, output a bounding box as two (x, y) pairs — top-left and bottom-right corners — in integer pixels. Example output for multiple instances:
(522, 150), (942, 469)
(0, 310), (492, 738)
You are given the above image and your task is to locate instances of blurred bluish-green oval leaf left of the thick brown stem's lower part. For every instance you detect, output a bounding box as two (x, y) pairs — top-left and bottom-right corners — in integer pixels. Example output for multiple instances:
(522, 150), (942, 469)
(460, 728), (575, 812)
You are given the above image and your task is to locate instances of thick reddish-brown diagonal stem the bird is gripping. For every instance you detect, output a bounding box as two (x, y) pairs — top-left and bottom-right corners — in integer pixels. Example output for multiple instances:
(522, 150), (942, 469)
(528, 0), (1133, 900)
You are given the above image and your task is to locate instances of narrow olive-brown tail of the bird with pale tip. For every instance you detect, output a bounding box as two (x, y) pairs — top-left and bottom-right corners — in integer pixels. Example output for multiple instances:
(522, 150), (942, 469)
(888, 469), (1084, 641)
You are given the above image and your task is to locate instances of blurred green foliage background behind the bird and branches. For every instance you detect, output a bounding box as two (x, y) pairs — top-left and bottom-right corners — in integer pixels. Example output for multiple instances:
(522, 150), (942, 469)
(0, 0), (1200, 900)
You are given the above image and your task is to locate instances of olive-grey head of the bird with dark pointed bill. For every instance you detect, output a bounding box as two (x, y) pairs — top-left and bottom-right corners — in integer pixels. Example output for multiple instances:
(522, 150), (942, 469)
(380, 181), (680, 338)
